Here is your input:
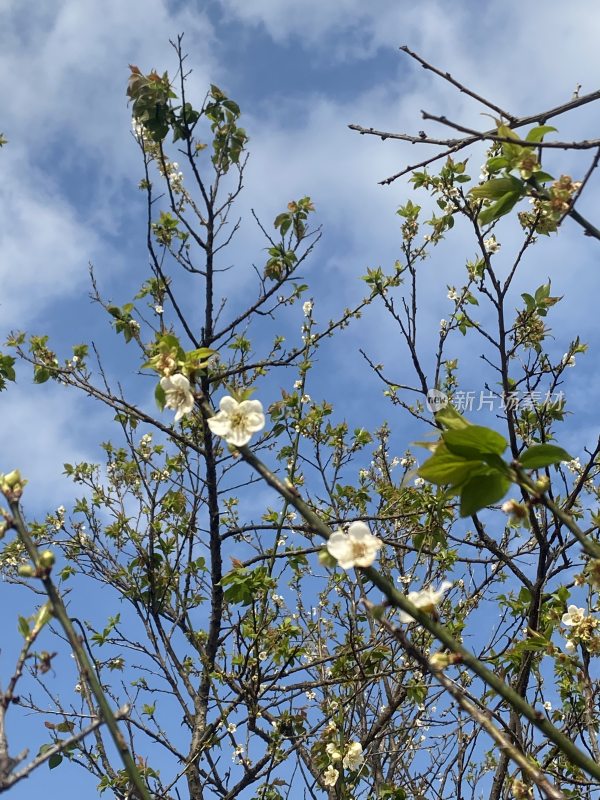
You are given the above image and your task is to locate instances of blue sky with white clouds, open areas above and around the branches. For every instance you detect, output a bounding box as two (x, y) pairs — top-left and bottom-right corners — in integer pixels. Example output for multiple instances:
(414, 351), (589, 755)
(0, 0), (600, 798)
